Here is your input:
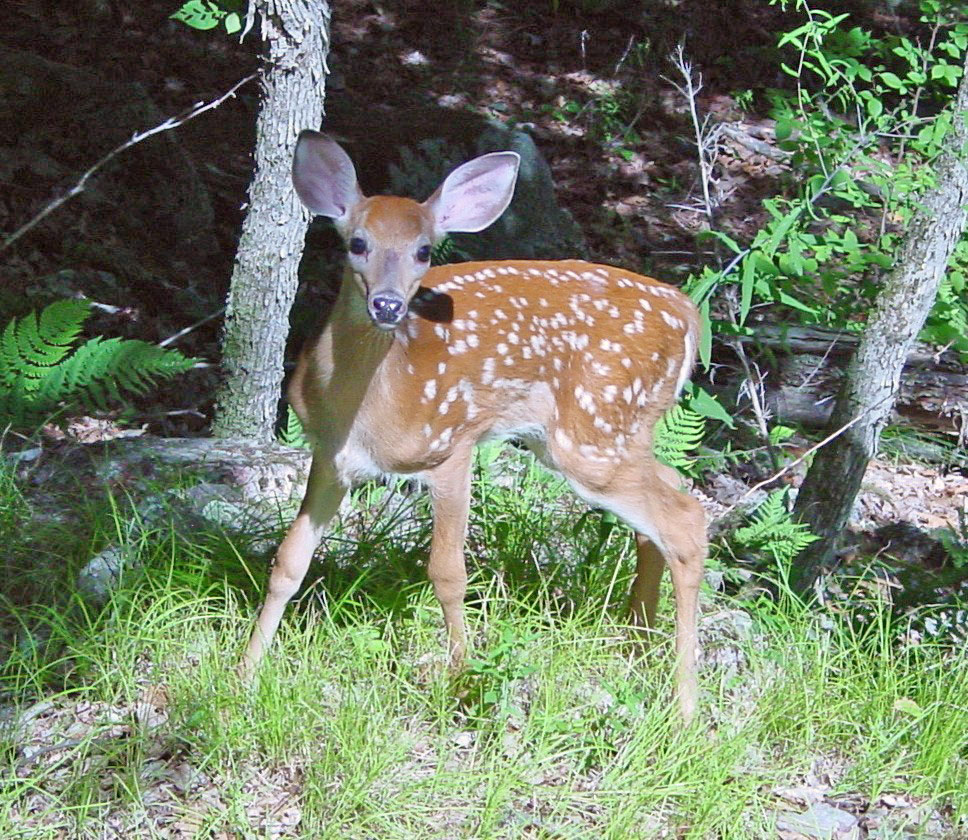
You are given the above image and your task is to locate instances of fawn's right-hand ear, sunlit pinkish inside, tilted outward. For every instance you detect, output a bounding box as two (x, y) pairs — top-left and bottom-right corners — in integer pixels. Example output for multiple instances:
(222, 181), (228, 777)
(424, 152), (521, 235)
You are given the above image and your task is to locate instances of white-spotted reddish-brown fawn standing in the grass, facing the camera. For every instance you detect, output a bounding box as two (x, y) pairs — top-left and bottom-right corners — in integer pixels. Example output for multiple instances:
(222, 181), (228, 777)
(244, 131), (706, 720)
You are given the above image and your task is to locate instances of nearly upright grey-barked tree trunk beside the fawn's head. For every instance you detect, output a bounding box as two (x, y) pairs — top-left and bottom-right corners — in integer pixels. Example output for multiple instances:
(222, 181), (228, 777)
(212, 0), (330, 442)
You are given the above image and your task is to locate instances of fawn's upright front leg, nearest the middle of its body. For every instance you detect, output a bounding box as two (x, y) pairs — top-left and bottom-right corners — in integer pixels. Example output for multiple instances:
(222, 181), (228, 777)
(425, 449), (473, 669)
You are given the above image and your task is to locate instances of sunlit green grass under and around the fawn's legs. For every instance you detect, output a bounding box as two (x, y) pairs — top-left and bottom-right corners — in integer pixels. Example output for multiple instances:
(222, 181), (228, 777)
(0, 452), (968, 840)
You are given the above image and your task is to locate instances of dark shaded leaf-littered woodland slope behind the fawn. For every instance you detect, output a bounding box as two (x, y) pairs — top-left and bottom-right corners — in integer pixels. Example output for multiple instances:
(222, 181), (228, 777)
(0, 0), (840, 434)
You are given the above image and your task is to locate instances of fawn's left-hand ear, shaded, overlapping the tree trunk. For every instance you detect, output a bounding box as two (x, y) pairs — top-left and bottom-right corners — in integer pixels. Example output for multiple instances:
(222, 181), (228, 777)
(292, 131), (363, 225)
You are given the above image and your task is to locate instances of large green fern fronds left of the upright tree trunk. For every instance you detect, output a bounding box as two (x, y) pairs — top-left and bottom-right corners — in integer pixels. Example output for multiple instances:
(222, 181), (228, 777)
(0, 300), (195, 426)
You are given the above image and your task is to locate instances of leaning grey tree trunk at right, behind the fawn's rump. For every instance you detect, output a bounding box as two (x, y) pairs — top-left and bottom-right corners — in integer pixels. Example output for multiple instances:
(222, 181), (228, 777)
(790, 55), (968, 595)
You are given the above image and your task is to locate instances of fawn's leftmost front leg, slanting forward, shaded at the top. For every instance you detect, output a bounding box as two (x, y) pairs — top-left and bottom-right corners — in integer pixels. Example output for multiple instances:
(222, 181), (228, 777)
(242, 456), (346, 678)
